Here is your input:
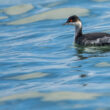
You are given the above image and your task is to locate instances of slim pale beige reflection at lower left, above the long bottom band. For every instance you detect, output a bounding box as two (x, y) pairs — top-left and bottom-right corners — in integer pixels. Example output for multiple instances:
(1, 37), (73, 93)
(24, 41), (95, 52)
(7, 72), (48, 80)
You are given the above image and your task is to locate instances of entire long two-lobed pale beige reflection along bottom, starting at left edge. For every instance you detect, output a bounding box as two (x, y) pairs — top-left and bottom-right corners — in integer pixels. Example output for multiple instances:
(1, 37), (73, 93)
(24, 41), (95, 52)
(0, 91), (102, 103)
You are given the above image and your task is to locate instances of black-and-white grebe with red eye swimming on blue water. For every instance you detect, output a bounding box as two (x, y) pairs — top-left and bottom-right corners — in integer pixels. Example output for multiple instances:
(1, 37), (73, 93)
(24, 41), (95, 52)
(64, 15), (110, 46)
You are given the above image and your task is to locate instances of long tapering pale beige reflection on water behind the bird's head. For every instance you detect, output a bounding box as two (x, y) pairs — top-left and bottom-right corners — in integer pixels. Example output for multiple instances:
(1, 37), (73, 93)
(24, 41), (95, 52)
(7, 8), (89, 25)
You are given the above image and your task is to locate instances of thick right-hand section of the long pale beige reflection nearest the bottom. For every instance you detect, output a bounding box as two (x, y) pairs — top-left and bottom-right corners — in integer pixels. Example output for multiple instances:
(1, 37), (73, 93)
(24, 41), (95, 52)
(40, 92), (99, 101)
